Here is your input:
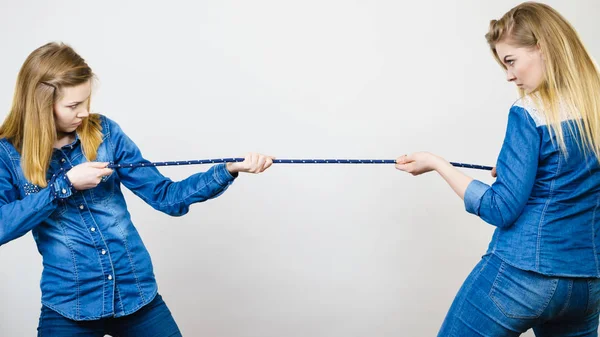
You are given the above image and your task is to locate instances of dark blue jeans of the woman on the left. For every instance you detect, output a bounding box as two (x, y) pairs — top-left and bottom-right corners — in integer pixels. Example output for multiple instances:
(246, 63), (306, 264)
(38, 294), (181, 337)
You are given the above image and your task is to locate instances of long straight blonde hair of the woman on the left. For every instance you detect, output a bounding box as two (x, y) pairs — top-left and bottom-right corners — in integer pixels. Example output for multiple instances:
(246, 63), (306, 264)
(0, 42), (102, 187)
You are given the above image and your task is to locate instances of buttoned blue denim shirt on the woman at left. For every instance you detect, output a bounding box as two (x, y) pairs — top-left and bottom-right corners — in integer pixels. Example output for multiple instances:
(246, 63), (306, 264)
(0, 116), (234, 320)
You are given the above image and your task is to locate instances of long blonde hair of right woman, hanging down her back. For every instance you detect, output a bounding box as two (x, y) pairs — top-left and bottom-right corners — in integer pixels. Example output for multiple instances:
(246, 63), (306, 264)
(485, 2), (600, 160)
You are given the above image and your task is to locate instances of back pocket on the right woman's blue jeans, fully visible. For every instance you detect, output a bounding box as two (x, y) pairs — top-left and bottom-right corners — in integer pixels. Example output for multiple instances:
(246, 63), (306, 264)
(490, 262), (558, 319)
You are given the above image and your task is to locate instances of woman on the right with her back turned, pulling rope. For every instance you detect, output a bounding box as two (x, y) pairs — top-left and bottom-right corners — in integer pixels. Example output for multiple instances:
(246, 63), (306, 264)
(397, 2), (600, 337)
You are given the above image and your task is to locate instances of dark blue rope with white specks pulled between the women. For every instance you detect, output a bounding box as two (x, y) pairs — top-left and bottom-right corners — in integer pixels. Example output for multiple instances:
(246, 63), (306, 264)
(108, 158), (492, 171)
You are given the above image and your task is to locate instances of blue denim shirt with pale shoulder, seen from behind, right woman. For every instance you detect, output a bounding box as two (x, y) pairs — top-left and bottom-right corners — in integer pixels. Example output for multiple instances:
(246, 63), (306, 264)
(464, 98), (600, 277)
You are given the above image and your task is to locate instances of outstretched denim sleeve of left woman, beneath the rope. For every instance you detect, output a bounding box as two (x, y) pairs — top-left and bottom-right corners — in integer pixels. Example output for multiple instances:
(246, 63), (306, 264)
(104, 117), (235, 216)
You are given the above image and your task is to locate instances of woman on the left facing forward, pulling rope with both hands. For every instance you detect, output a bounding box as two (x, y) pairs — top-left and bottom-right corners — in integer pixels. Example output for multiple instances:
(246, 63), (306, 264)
(0, 43), (273, 337)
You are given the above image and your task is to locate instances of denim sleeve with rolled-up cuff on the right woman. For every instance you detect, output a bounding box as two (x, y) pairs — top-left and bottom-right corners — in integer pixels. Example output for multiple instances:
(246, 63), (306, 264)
(464, 106), (541, 227)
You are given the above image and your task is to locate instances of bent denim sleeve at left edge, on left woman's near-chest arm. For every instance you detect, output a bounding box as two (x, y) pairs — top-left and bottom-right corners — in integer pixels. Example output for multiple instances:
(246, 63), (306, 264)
(0, 150), (73, 246)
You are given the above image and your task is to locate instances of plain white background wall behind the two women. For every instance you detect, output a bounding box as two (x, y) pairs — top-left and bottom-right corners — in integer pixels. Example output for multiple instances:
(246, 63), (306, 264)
(0, 0), (600, 337)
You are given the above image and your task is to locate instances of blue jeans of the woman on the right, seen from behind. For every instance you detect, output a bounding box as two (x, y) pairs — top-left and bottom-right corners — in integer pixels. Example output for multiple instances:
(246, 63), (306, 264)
(438, 254), (600, 337)
